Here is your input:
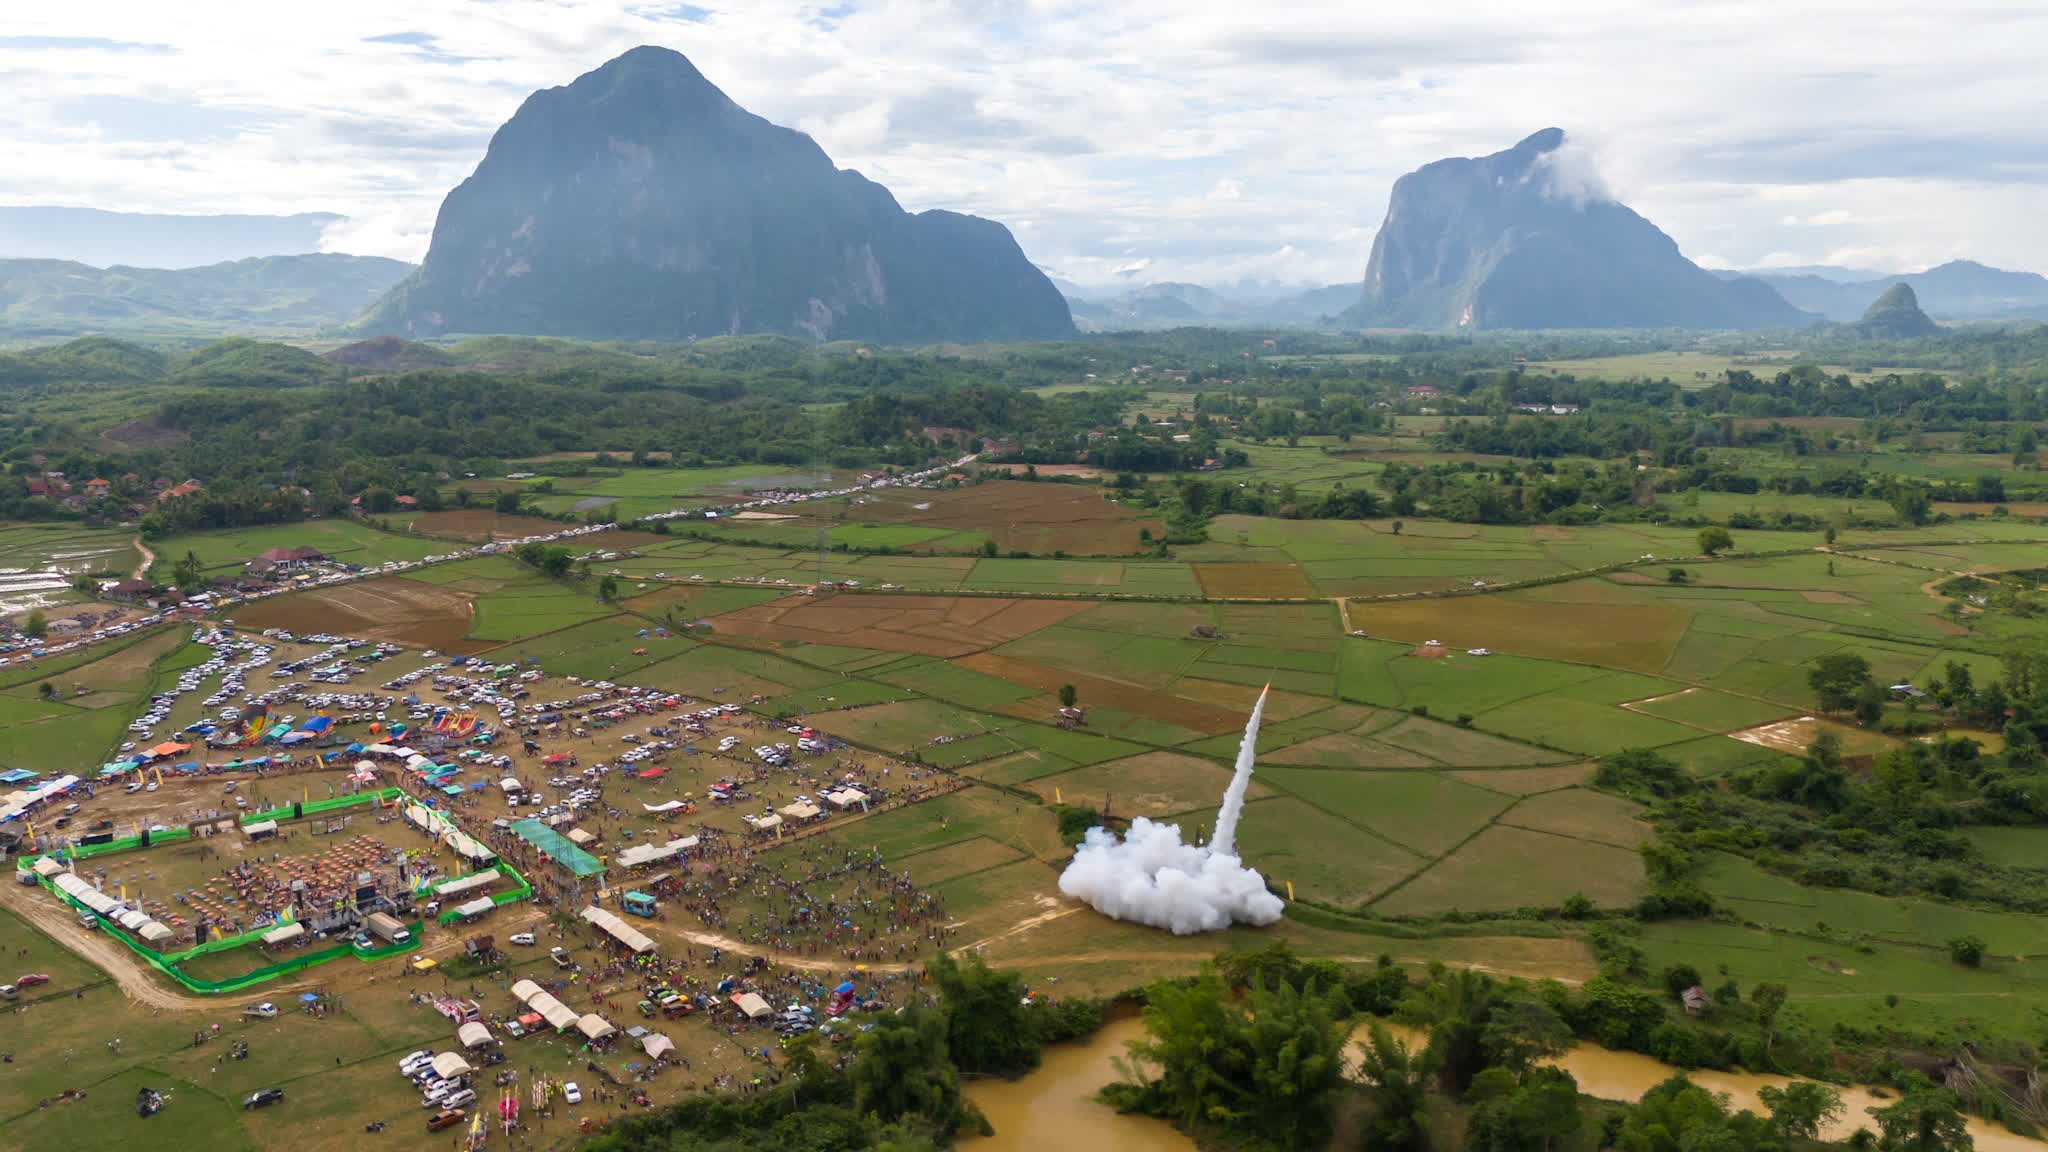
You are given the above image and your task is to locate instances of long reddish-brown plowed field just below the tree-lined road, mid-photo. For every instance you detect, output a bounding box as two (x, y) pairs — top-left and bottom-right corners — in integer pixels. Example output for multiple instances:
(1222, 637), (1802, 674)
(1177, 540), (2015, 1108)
(711, 592), (1094, 656)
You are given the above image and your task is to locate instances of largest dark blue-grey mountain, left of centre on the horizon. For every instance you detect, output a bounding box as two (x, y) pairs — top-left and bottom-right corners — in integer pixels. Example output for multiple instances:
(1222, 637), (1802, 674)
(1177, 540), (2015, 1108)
(362, 47), (1073, 342)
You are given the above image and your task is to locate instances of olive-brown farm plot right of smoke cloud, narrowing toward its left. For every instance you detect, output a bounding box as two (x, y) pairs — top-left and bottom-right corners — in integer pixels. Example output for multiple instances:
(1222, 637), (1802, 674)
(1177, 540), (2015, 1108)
(1372, 824), (1649, 916)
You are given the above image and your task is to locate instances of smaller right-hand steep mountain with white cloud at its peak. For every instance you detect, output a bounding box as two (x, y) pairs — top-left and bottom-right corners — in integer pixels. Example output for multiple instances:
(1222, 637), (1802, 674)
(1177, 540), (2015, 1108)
(1346, 127), (1815, 328)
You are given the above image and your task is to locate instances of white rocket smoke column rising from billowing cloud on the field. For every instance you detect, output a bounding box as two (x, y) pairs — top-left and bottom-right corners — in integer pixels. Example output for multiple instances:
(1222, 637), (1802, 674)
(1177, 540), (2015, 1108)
(1059, 691), (1284, 935)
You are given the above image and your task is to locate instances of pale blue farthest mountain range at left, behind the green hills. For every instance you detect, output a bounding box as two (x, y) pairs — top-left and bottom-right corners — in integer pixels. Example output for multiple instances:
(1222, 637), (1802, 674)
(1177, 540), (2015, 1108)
(0, 205), (346, 269)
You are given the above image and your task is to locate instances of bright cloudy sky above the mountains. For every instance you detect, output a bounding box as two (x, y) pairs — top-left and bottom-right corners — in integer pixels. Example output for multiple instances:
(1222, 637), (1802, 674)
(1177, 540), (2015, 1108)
(0, 0), (2048, 287)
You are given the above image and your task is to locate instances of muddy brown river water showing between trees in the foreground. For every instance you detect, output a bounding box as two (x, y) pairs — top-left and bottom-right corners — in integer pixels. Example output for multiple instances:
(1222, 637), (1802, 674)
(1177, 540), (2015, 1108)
(961, 1017), (2048, 1152)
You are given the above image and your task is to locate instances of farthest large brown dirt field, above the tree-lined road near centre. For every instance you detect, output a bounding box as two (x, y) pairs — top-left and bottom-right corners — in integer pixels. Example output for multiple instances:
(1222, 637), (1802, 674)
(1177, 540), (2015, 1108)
(846, 480), (1165, 556)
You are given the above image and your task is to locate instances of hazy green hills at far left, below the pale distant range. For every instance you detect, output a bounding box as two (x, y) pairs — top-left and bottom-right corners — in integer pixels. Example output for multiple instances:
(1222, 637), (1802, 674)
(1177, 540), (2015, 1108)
(0, 252), (412, 340)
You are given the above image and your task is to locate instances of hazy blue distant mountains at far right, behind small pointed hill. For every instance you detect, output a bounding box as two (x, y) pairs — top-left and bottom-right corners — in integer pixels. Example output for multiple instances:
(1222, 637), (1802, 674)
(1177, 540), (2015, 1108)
(1714, 260), (2048, 324)
